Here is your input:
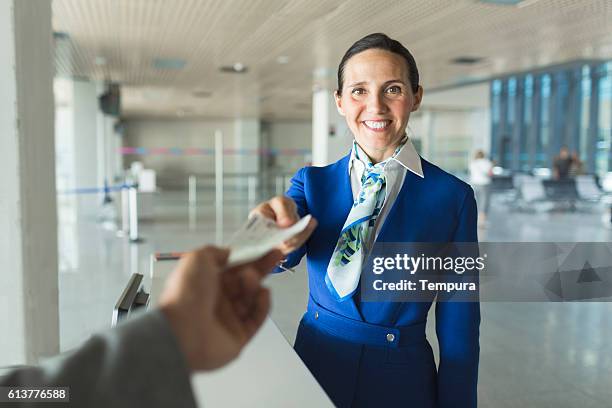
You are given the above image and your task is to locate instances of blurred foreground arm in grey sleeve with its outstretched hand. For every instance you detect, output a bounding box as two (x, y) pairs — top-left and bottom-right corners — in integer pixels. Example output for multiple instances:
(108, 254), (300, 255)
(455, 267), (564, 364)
(0, 247), (281, 408)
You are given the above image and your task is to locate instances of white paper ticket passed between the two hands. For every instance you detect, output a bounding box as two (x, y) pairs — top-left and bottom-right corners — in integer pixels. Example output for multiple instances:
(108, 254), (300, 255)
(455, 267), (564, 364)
(228, 214), (311, 266)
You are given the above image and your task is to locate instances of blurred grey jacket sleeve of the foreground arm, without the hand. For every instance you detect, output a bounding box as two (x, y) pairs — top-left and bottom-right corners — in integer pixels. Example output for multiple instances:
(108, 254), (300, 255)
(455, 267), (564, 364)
(0, 310), (196, 408)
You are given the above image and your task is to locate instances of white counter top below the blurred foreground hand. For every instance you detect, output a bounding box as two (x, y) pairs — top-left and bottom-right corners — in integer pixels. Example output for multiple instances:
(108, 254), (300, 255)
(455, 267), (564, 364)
(148, 253), (333, 408)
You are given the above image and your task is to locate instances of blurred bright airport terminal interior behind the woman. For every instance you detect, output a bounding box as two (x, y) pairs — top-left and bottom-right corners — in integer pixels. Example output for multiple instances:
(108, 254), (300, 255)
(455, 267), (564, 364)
(0, 0), (612, 408)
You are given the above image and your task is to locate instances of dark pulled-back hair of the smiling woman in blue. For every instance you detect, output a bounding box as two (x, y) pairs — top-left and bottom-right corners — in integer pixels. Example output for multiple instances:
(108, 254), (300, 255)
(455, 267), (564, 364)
(337, 33), (419, 95)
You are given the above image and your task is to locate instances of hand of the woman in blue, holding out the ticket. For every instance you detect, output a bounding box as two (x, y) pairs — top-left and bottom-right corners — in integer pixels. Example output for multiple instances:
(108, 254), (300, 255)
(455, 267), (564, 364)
(251, 196), (317, 255)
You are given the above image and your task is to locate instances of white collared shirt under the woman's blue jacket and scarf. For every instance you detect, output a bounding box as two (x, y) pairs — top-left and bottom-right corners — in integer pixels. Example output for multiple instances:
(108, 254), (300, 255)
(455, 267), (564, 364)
(348, 138), (425, 248)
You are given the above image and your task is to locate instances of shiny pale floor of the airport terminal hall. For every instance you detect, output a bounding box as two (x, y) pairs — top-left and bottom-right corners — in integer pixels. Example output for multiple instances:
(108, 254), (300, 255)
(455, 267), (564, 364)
(60, 192), (612, 408)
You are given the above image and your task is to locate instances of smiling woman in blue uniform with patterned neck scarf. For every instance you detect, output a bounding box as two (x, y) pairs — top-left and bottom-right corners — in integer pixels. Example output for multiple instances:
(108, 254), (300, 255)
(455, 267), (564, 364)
(255, 34), (480, 407)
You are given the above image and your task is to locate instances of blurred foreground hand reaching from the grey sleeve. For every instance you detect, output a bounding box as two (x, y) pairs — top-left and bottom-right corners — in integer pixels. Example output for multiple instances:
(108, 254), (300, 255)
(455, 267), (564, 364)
(160, 247), (282, 370)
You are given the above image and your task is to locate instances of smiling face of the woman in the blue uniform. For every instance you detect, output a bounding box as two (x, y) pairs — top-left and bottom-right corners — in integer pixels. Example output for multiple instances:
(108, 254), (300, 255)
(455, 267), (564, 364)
(336, 49), (423, 162)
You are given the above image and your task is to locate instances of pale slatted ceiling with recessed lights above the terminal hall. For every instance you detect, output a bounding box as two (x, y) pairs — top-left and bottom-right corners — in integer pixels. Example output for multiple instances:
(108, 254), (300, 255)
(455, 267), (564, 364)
(53, 0), (612, 119)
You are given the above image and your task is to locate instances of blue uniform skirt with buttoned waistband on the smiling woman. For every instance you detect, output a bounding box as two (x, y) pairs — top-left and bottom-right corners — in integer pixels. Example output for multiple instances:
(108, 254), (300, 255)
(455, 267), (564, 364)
(294, 298), (437, 408)
